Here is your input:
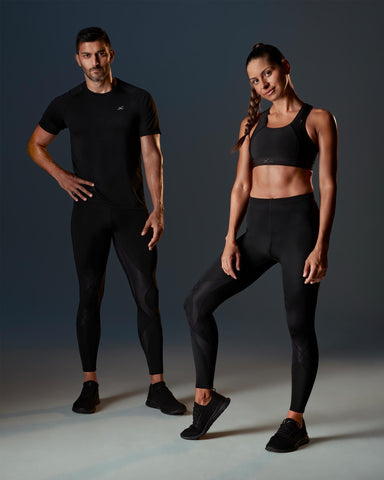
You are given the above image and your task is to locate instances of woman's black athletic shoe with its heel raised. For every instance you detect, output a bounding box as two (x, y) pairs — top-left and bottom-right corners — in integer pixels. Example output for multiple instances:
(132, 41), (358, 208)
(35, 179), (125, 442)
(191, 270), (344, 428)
(180, 391), (231, 440)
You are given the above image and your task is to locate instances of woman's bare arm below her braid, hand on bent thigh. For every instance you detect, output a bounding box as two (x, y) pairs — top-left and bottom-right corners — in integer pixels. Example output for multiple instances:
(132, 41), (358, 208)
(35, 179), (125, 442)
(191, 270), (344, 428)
(221, 118), (252, 279)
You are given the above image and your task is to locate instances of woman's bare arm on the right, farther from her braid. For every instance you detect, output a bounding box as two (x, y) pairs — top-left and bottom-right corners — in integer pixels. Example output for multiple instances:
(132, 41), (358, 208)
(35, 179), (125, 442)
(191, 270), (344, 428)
(303, 110), (337, 283)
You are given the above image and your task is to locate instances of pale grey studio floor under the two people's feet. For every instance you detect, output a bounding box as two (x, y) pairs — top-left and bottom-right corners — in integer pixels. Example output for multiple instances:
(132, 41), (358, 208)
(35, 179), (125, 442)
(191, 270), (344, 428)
(0, 346), (384, 480)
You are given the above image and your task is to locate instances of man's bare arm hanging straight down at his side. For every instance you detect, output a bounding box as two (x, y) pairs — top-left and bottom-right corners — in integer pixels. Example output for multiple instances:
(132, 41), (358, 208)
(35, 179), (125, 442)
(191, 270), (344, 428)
(140, 134), (164, 250)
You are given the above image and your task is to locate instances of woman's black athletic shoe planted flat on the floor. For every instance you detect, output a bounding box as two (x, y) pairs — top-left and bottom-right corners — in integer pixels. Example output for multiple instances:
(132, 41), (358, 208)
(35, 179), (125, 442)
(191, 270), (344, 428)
(265, 418), (309, 453)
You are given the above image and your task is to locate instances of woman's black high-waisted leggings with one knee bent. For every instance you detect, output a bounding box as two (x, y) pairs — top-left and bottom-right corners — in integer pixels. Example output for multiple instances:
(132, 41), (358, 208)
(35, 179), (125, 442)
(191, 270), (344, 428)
(185, 193), (319, 412)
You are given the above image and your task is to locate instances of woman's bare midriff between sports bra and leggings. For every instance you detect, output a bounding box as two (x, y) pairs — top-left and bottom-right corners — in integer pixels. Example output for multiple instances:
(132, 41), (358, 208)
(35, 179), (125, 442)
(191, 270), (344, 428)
(250, 165), (313, 198)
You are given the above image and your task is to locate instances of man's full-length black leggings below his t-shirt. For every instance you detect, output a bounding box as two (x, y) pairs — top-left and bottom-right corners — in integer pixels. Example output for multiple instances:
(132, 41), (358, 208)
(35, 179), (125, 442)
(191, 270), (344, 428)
(71, 198), (163, 375)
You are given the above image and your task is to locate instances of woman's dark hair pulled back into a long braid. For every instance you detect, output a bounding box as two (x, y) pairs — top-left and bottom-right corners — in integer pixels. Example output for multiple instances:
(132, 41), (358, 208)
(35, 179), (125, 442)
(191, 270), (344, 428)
(232, 43), (284, 152)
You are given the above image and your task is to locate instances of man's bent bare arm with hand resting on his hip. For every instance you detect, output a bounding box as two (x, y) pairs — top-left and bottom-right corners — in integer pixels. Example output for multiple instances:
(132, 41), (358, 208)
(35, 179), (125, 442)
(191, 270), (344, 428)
(27, 125), (94, 202)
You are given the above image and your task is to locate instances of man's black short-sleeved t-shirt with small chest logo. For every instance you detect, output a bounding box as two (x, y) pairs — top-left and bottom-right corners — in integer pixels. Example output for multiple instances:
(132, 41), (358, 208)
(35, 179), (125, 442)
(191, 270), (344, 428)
(39, 79), (160, 209)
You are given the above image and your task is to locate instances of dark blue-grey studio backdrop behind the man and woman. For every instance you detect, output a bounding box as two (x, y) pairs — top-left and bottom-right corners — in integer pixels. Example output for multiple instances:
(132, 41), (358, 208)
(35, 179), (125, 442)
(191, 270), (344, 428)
(1, 1), (384, 355)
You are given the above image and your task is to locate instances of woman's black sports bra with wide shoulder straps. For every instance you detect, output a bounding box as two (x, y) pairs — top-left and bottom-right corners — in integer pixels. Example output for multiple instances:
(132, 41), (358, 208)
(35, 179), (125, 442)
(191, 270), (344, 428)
(249, 103), (319, 170)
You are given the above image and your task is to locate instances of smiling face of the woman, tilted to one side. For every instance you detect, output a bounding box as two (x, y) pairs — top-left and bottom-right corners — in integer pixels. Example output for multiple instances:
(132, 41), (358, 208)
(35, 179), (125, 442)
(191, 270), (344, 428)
(247, 56), (290, 102)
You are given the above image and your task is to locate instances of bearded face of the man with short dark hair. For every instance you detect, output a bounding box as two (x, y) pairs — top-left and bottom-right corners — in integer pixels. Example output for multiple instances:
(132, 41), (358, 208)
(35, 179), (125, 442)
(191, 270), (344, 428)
(76, 40), (115, 82)
